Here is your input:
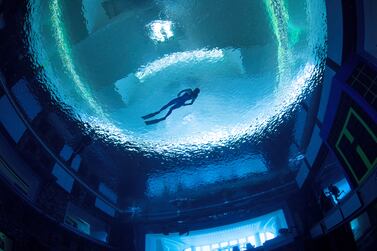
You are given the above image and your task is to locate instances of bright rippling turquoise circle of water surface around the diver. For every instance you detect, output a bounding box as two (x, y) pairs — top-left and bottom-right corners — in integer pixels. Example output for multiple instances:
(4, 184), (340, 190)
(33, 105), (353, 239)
(28, 0), (326, 153)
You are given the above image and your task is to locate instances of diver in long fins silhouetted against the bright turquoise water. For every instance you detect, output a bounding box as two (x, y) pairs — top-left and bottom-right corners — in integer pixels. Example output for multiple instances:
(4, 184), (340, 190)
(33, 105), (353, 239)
(142, 88), (200, 125)
